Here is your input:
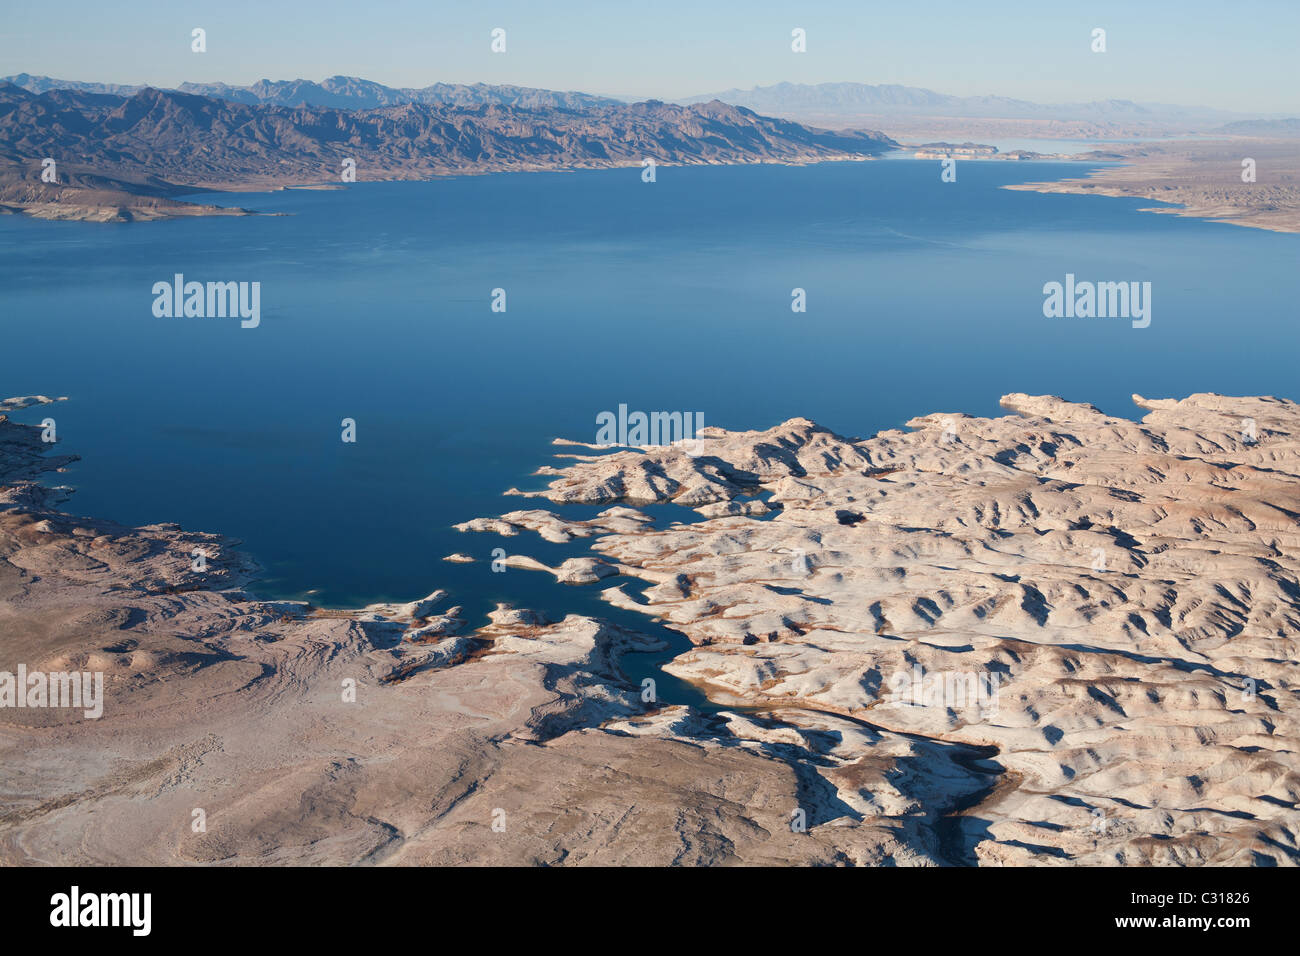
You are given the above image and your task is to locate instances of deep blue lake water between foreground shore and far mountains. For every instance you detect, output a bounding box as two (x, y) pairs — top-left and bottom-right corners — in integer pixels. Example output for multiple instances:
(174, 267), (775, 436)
(0, 160), (1300, 616)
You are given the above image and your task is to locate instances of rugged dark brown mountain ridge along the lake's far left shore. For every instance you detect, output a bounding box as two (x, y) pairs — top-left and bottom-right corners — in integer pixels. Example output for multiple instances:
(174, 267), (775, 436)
(0, 83), (897, 219)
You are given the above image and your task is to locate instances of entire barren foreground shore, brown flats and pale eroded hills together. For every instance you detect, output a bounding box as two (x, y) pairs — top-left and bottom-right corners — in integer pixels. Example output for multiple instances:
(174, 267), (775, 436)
(0, 394), (1300, 865)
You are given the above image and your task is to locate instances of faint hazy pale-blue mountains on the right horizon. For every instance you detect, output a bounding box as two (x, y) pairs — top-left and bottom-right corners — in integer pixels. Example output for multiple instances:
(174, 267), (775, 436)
(679, 83), (1261, 122)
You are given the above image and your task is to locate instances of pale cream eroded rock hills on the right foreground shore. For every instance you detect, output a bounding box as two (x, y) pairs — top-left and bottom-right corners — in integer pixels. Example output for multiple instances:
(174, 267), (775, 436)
(460, 394), (1300, 864)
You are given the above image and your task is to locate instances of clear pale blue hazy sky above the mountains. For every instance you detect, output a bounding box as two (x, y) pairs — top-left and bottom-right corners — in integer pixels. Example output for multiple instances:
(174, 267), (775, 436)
(0, 0), (1300, 113)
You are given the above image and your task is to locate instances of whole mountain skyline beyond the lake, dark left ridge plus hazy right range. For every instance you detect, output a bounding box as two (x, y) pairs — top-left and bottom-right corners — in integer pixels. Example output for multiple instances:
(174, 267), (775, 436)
(0, 73), (1300, 219)
